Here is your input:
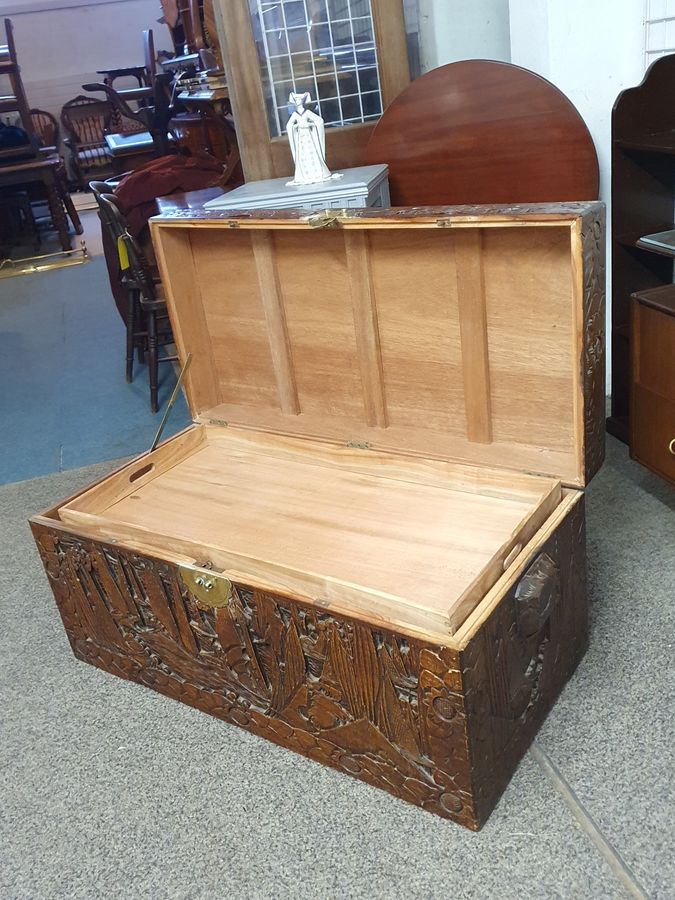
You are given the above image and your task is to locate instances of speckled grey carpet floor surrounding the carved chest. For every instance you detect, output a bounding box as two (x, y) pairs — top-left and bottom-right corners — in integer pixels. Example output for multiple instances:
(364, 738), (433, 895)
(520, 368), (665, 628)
(0, 442), (675, 900)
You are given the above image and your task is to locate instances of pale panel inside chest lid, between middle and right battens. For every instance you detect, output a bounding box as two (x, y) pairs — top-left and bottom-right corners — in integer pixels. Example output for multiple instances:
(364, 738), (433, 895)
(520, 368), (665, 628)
(368, 229), (465, 434)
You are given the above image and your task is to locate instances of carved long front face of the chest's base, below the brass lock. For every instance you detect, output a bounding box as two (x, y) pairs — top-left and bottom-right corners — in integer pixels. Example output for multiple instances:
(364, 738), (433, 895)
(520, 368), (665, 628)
(33, 525), (476, 828)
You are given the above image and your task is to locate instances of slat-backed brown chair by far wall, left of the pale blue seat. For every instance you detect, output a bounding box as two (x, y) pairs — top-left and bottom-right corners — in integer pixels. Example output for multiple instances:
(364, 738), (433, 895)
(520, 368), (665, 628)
(61, 95), (113, 189)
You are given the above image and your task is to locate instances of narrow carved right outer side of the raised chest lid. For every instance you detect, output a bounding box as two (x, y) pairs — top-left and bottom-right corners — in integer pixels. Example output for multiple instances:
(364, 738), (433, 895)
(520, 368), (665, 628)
(581, 205), (606, 484)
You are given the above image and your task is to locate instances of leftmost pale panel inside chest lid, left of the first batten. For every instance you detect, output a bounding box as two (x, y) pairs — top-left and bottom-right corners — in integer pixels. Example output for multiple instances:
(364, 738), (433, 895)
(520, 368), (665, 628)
(189, 230), (279, 409)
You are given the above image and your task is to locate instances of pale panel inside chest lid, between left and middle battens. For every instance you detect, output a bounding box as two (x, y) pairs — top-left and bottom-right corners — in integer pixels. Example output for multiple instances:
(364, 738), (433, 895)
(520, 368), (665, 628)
(274, 229), (366, 422)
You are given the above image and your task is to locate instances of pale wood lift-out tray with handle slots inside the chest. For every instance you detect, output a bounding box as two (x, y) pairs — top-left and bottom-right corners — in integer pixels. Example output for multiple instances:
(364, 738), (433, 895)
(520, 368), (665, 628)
(60, 429), (561, 628)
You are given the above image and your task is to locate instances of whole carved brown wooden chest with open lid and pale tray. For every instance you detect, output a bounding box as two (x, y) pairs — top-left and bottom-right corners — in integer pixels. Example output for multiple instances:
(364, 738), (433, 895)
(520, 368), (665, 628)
(32, 204), (605, 829)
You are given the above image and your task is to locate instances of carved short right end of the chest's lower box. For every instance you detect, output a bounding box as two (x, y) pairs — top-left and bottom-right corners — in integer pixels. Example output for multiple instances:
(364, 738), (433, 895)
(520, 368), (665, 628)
(461, 498), (588, 824)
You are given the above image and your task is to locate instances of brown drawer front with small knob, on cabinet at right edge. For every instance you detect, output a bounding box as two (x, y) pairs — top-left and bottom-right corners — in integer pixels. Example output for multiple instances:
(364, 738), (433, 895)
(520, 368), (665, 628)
(630, 385), (675, 483)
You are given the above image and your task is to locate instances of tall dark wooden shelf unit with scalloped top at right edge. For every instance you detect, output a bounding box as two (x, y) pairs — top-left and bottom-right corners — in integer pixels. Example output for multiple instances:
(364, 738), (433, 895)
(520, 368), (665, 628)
(607, 55), (675, 441)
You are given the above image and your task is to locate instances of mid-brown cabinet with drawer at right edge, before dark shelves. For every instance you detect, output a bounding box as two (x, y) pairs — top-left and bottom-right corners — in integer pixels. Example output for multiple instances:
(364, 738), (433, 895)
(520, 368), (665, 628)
(630, 284), (675, 484)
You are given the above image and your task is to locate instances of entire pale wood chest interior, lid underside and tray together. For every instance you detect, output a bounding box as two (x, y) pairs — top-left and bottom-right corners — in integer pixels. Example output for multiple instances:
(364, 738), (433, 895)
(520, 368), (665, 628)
(51, 207), (604, 636)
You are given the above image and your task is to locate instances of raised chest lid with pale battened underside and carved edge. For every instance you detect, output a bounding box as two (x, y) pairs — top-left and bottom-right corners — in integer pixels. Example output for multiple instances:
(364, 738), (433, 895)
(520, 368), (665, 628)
(151, 203), (605, 486)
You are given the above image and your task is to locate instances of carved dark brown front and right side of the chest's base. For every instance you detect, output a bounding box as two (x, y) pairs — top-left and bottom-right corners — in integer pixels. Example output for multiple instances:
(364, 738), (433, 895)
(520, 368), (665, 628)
(33, 502), (586, 828)
